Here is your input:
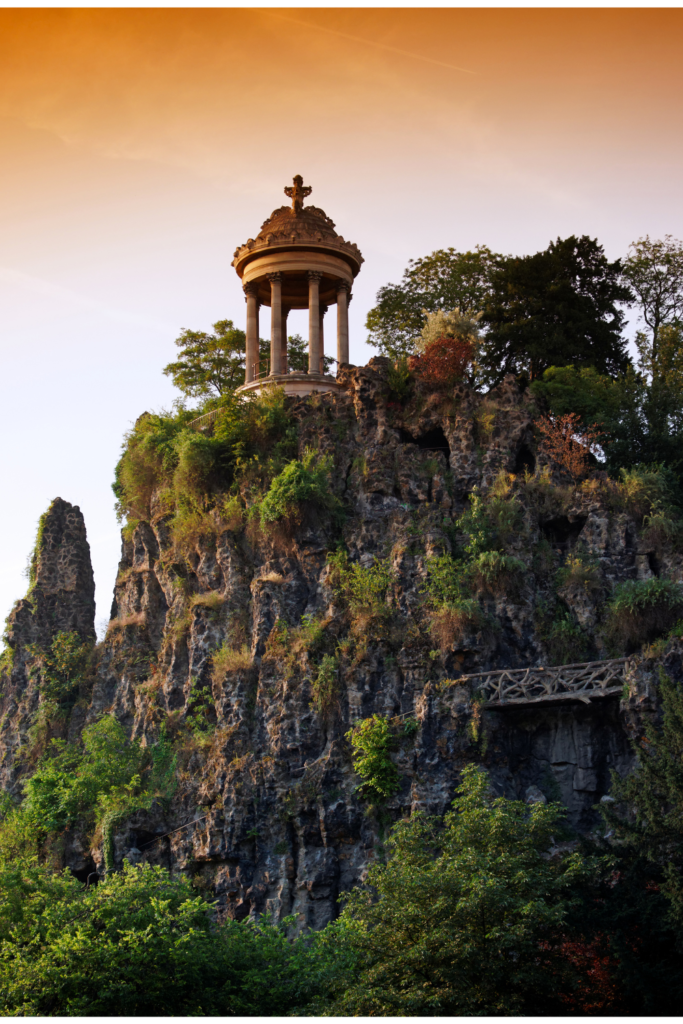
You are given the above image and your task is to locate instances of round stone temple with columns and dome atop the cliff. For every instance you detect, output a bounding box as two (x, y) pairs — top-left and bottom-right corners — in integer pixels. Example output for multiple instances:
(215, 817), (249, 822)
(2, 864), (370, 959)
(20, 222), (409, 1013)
(232, 174), (362, 394)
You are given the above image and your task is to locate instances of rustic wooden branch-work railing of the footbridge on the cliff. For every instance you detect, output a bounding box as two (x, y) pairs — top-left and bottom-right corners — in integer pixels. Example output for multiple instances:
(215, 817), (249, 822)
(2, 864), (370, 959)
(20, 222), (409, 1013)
(454, 657), (627, 708)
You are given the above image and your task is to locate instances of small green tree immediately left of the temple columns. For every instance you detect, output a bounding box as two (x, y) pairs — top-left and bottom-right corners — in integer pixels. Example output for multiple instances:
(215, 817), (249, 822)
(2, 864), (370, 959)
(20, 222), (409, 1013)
(164, 321), (246, 398)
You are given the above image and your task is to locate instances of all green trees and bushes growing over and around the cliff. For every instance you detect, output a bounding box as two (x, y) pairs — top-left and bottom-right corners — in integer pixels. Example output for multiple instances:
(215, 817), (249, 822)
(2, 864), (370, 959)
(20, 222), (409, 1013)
(0, 230), (683, 1016)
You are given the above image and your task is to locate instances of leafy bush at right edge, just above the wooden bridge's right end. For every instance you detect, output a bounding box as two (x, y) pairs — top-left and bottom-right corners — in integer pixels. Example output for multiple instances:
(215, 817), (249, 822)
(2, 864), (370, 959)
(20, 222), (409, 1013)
(605, 577), (683, 653)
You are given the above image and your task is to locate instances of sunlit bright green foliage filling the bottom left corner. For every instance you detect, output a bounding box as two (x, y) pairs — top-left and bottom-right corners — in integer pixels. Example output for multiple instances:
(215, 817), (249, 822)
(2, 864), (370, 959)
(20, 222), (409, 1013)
(0, 865), (312, 1017)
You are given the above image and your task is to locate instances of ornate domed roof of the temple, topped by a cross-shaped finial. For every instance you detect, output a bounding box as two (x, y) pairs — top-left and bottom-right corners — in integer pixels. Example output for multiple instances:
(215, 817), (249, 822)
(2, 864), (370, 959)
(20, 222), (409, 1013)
(232, 174), (364, 276)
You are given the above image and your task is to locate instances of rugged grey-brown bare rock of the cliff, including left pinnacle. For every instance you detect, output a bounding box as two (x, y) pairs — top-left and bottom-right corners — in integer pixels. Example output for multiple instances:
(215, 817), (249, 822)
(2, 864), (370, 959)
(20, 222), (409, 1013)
(0, 359), (680, 928)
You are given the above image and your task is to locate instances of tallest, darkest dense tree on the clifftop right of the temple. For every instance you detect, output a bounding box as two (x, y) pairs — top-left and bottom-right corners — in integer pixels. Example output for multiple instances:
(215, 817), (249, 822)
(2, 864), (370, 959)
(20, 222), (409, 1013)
(480, 236), (632, 383)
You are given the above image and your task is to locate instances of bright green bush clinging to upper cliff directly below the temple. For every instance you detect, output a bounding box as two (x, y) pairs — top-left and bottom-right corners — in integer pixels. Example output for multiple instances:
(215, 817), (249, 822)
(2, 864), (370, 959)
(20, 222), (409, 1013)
(260, 449), (341, 526)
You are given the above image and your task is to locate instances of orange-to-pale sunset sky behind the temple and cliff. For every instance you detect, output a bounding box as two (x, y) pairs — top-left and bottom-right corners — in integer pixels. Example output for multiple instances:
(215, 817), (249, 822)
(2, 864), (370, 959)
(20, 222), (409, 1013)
(0, 8), (683, 621)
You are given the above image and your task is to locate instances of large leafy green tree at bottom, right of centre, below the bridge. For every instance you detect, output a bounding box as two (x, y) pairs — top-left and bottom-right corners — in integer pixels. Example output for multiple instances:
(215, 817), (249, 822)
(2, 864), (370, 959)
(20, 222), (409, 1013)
(317, 765), (587, 1017)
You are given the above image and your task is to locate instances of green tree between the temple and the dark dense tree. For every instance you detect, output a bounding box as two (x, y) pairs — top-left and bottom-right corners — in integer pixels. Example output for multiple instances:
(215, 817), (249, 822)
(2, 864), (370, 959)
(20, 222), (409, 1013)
(366, 246), (503, 359)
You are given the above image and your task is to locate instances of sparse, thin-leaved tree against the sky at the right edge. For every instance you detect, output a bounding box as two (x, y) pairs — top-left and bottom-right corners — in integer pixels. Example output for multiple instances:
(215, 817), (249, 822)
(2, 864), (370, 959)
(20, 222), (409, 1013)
(624, 234), (683, 361)
